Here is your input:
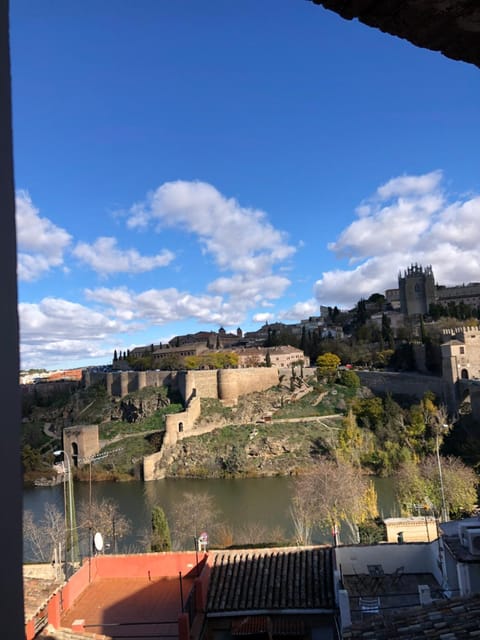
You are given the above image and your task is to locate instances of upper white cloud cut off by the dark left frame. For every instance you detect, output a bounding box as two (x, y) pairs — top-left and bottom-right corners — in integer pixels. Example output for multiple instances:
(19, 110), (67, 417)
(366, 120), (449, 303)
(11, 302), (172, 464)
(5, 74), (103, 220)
(15, 191), (71, 282)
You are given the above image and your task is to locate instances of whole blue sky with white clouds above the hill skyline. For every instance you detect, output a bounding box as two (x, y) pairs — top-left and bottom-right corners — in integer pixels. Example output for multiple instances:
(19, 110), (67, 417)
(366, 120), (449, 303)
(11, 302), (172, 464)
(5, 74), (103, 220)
(10, 0), (480, 369)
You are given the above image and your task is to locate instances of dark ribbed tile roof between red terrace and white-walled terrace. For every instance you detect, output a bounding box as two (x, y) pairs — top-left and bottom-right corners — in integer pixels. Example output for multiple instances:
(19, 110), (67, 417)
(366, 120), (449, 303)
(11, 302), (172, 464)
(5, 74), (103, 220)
(207, 547), (335, 613)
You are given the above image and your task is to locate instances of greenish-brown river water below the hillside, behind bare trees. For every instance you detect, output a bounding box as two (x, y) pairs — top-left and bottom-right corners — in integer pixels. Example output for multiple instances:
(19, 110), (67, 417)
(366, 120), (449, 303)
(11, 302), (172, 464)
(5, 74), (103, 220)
(23, 477), (398, 561)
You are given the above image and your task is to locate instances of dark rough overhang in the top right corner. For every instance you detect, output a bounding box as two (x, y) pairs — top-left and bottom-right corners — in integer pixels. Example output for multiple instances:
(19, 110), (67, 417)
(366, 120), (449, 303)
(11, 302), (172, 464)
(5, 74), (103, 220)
(311, 0), (480, 67)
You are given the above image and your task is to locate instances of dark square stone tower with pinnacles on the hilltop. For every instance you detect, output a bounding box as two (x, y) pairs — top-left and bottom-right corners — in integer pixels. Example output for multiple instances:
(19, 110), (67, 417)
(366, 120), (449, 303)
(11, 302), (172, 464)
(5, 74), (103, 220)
(398, 264), (436, 316)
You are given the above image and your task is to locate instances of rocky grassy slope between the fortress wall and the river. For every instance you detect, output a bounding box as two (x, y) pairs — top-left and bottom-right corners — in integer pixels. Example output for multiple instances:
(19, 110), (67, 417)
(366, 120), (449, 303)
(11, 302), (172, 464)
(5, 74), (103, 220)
(162, 378), (352, 478)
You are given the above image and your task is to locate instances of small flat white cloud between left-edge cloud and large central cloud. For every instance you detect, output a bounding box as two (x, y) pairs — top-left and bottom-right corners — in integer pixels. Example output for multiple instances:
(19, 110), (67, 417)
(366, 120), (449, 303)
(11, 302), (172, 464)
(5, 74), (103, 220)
(73, 237), (175, 275)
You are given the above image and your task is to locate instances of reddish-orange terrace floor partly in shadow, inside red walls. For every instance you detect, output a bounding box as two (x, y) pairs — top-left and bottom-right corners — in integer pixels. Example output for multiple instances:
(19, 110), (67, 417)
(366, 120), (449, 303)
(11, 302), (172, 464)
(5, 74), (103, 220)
(61, 578), (194, 640)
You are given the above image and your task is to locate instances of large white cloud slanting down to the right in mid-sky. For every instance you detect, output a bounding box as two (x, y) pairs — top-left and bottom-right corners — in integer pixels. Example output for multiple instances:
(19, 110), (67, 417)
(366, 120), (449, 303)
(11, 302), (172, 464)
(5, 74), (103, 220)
(127, 180), (295, 275)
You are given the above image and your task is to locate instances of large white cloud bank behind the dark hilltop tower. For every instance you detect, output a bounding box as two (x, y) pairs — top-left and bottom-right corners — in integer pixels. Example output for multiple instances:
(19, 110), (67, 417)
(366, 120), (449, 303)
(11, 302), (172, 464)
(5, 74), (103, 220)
(314, 171), (480, 307)
